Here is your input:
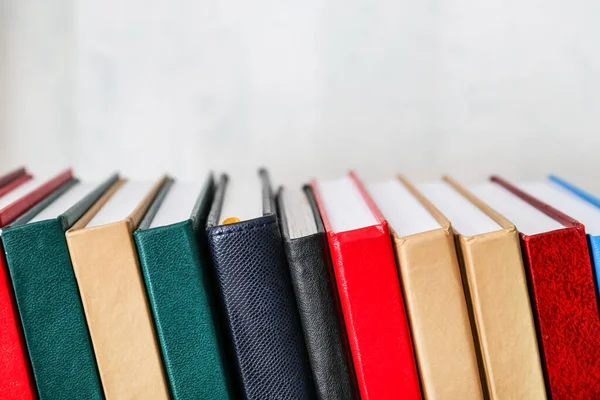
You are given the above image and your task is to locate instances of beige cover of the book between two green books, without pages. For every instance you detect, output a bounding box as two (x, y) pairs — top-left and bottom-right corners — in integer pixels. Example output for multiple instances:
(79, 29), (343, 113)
(66, 177), (169, 400)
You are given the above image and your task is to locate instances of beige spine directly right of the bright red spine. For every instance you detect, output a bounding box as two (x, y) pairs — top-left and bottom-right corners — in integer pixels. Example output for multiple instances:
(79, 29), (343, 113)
(394, 228), (483, 400)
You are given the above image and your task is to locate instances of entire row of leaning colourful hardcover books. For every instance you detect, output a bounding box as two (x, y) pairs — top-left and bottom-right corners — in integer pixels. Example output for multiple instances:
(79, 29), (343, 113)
(0, 169), (600, 400)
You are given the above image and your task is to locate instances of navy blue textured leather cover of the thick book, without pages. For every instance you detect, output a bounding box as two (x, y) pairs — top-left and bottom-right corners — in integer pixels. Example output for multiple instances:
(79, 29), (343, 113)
(206, 170), (314, 400)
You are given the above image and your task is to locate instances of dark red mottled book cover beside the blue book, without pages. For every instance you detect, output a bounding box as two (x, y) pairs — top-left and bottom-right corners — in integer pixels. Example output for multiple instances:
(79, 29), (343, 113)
(491, 177), (600, 400)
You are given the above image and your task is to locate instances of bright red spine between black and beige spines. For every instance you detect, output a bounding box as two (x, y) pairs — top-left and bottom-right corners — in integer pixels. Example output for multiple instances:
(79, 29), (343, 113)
(329, 225), (421, 400)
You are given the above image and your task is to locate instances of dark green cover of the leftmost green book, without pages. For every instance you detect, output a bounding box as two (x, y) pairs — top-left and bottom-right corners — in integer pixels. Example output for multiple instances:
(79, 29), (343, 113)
(2, 175), (118, 399)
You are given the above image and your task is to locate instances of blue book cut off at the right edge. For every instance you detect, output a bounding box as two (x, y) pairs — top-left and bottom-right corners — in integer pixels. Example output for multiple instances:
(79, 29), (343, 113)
(552, 175), (600, 307)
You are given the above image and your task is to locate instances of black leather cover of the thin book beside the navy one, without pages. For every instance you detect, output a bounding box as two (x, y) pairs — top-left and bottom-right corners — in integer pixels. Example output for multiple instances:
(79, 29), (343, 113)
(278, 186), (358, 400)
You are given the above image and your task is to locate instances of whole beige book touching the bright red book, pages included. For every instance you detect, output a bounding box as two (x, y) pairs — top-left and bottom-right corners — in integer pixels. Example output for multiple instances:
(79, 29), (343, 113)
(367, 177), (483, 399)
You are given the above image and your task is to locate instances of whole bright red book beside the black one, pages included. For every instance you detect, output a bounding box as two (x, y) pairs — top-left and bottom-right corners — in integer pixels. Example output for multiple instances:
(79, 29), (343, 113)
(312, 173), (421, 400)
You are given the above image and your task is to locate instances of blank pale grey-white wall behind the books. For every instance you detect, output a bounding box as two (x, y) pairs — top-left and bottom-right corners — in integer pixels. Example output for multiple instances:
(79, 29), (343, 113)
(0, 0), (600, 190)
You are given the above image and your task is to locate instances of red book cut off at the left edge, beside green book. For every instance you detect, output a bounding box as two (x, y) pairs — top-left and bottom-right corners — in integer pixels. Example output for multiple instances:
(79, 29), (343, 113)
(0, 170), (73, 400)
